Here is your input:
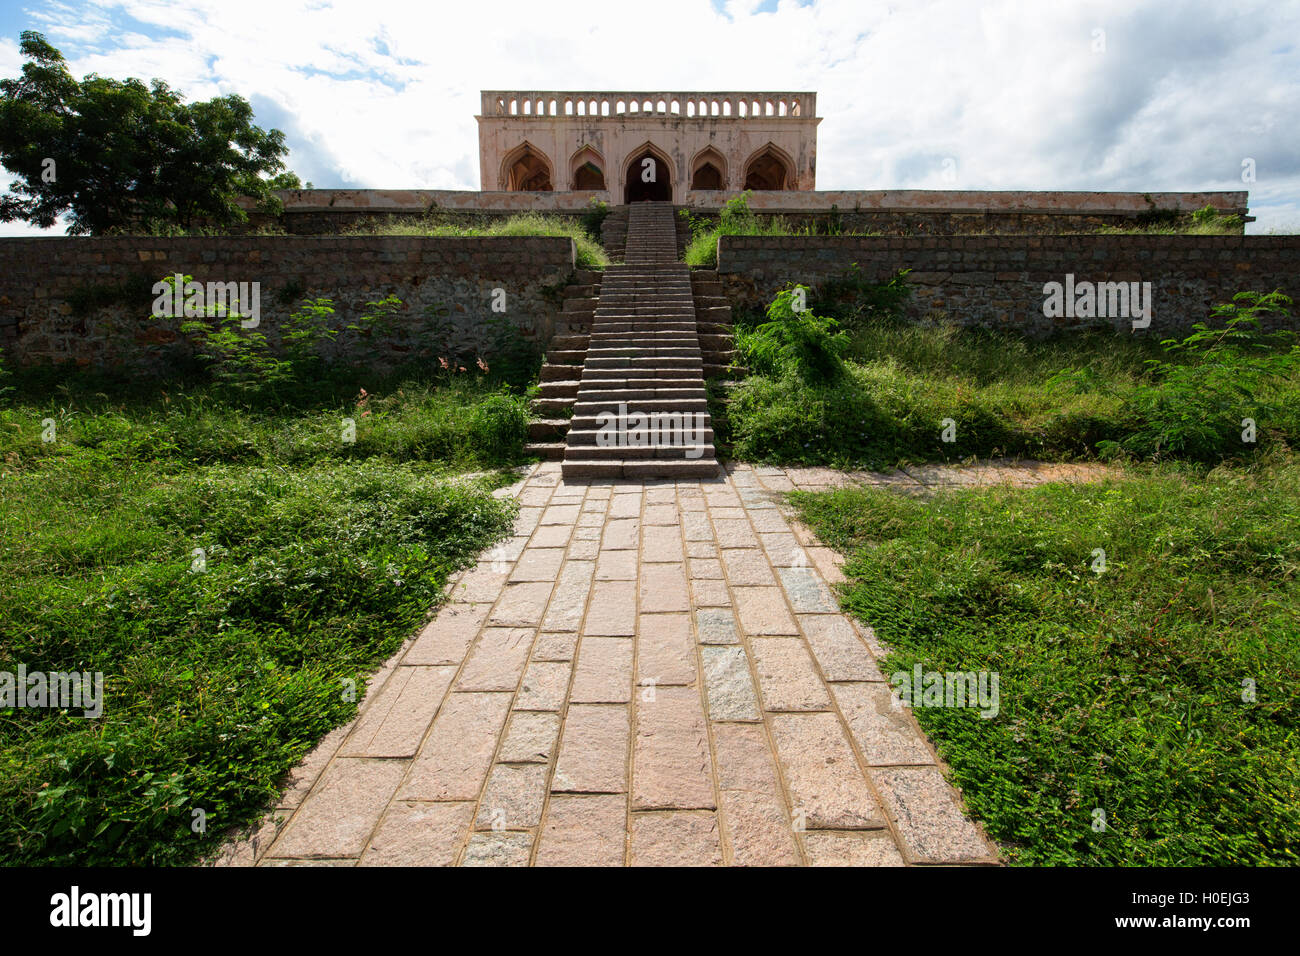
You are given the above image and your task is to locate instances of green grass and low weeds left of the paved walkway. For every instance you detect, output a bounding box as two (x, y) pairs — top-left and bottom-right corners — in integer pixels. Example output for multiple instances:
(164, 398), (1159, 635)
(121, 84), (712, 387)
(0, 376), (527, 865)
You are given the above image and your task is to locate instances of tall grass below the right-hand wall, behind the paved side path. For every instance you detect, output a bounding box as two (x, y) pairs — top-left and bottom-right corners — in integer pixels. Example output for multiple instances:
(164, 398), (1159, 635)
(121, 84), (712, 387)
(714, 310), (1300, 468)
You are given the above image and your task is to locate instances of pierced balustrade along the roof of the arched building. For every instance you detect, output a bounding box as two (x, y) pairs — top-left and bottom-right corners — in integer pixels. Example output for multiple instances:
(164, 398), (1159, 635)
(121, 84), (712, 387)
(482, 90), (816, 120)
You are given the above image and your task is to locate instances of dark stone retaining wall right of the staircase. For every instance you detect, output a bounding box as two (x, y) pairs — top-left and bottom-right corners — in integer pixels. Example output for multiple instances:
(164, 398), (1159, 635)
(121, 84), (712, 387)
(718, 235), (1300, 337)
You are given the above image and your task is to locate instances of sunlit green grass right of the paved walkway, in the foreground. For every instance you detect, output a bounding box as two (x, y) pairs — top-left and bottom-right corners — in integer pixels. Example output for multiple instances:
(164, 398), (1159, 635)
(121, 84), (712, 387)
(793, 455), (1300, 866)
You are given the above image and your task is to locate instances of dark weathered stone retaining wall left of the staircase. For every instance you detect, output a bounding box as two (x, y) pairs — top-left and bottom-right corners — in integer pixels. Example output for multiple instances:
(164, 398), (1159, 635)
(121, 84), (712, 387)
(0, 237), (573, 369)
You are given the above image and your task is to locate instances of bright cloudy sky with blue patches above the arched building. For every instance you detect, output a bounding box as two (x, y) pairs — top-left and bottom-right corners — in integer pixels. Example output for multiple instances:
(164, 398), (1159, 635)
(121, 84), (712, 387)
(0, 0), (1300, 235)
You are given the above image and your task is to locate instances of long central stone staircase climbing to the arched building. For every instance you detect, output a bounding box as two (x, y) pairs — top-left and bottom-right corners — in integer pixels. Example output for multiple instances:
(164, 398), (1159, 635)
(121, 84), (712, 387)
(559, 203), (729, 479)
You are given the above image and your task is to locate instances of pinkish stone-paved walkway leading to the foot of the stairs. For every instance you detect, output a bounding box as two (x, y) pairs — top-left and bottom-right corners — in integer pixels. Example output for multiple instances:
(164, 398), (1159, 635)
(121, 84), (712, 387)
(210, 462), (1005, 866)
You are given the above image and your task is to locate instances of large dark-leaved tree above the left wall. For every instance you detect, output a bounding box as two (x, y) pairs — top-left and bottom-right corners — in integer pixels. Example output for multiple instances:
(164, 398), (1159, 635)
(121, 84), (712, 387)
(0, 31), (297, 235)
